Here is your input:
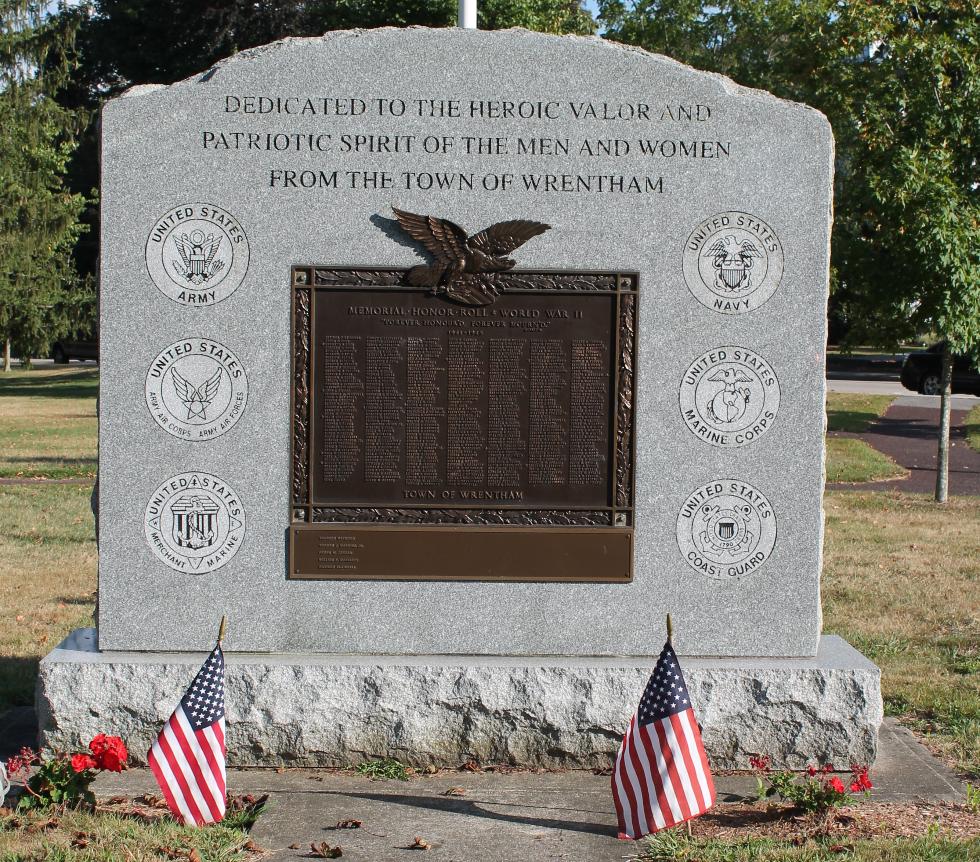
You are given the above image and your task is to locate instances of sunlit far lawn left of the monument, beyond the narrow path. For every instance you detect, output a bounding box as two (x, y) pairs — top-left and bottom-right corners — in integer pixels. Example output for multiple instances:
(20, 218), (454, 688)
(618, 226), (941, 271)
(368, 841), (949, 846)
(0, 367), (99, 479)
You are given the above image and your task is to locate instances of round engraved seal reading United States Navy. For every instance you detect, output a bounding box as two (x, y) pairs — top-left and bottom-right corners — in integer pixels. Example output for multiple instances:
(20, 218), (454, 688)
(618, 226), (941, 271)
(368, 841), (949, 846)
(684, 212), (783, 314)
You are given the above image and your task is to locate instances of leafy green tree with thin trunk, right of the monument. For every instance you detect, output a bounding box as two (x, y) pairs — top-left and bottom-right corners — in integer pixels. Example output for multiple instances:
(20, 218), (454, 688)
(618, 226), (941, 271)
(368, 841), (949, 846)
(600, 0), (980, 501)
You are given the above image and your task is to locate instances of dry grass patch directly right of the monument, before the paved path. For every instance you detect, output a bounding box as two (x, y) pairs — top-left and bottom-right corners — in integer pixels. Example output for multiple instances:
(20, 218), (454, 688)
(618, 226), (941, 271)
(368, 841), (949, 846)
(822, 491), (980, 782)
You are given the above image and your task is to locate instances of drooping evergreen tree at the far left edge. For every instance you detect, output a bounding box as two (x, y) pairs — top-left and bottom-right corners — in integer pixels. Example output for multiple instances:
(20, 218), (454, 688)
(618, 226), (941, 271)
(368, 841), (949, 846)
(0, 0), (87, 371)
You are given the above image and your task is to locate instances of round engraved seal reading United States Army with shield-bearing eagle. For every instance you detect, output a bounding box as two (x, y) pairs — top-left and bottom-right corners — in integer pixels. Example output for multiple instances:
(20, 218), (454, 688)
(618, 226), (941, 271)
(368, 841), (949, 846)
(146, 204), (249, 305)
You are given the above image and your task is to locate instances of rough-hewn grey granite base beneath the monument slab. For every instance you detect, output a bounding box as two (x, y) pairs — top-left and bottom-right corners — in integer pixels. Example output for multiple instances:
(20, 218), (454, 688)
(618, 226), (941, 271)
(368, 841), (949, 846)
(37, 629), (882, 769)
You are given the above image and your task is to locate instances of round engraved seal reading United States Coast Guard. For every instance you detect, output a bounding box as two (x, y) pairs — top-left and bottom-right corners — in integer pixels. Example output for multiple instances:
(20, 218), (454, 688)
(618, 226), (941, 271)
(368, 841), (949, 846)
(677, 479), (776, 580)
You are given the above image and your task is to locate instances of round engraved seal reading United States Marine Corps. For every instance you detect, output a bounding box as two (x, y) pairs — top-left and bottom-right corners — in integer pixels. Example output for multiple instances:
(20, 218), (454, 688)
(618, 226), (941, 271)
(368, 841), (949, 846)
(680, 347), (779, 448)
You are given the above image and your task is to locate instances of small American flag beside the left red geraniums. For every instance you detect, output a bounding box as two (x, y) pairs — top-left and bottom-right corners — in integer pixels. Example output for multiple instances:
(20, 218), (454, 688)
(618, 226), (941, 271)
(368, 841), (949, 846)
(148, 641), (226, 826)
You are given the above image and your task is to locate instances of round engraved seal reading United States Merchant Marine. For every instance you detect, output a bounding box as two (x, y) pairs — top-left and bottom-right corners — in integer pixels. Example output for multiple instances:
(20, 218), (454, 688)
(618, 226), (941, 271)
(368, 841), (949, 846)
(144, 471), (245, 575)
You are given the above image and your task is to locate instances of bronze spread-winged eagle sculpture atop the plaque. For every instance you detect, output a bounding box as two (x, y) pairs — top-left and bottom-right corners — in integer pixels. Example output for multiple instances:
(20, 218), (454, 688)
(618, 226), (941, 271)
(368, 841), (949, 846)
(392, 207), (551, 305)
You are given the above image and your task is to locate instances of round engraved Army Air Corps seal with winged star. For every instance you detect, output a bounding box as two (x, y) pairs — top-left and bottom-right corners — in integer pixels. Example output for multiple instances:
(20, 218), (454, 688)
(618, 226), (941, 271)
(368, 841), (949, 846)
(145, 338), (248, 443)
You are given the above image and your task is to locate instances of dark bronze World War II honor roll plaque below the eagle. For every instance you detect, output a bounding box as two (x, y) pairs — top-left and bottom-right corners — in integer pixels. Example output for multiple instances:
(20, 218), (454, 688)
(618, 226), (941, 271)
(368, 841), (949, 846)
(289, 266), (637, 582)
